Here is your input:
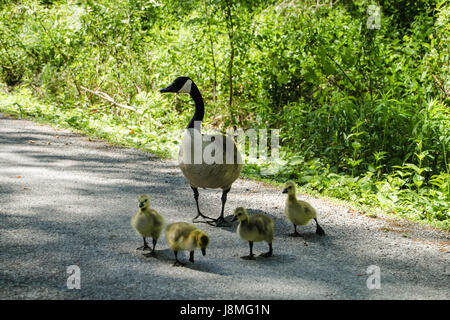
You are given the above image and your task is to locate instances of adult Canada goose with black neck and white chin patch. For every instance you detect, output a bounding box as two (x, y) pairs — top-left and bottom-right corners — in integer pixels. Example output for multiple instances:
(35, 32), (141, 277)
(160, 77), (242, 226)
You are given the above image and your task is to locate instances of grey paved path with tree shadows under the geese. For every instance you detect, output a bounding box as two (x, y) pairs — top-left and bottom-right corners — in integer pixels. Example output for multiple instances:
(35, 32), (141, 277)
(0, 114), (450, 299)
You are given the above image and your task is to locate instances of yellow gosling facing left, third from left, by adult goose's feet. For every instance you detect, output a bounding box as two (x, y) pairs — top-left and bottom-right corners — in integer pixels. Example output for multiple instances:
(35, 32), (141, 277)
(234, 207), (274, 260)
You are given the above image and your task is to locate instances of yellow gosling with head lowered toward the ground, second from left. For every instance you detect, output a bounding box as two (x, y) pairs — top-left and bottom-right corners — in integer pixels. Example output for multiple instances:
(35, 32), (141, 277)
(166, 222), (209, 266)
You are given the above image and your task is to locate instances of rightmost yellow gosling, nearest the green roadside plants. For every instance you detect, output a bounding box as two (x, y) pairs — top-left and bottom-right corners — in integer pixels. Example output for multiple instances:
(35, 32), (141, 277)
(283, 181), (325, 237)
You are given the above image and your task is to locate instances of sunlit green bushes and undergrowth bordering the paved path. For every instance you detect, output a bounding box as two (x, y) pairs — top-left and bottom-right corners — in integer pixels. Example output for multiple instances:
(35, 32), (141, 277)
(0, 0), (450, 229)
